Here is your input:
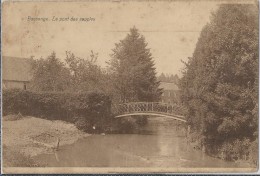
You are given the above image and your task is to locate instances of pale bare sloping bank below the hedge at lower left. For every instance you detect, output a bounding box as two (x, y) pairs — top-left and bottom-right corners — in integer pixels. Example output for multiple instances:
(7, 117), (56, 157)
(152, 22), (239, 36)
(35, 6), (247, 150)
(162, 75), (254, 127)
(2, 115), (89, 167)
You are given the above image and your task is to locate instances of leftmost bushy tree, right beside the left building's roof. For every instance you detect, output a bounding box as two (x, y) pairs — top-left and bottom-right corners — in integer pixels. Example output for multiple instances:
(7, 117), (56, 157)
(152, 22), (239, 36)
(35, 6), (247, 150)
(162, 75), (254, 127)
(32, 52), (71, 91)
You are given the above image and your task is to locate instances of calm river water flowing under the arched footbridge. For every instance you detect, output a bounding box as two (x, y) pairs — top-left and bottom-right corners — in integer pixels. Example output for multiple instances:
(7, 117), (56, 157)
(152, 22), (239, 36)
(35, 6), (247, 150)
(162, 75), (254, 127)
(35, 118), (246, 168)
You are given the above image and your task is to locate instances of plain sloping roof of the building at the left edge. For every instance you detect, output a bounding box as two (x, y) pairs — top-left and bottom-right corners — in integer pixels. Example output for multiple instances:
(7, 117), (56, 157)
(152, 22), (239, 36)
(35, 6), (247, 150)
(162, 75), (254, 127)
(2, 56), (32, 81)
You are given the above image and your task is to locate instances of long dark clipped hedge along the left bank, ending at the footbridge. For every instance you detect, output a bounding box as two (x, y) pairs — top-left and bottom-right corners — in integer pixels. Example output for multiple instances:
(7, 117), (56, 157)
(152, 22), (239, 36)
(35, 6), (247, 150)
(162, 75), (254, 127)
(3, 89), (111, 132)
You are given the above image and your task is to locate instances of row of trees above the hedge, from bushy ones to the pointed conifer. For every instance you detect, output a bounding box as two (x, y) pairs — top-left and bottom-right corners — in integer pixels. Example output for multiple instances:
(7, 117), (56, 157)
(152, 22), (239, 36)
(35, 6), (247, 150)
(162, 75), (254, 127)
(32, 27), (162, 102)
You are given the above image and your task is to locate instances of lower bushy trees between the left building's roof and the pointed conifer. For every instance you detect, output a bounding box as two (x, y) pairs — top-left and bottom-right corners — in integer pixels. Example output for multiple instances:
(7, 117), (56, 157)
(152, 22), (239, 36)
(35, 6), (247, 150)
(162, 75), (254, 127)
(31, 51), (108, 92)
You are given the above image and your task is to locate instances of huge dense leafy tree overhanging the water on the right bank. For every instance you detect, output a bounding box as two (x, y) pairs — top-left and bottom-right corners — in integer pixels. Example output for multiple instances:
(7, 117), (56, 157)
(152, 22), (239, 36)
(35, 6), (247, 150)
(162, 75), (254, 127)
(180, 5), (259, 162)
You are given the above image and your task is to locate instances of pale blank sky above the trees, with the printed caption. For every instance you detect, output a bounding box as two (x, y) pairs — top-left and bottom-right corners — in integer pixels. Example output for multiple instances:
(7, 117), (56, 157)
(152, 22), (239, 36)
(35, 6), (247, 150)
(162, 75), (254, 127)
(2, 1), (220, 76)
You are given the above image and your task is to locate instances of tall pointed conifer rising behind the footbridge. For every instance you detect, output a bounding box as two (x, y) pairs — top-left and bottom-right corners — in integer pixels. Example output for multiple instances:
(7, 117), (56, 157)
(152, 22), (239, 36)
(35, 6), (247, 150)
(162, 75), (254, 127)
(109, 27), (161, 102)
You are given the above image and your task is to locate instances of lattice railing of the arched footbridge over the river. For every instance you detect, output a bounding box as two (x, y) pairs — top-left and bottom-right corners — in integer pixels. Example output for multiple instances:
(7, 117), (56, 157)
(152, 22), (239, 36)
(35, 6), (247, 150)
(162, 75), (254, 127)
(114, 102), (185, 115)
